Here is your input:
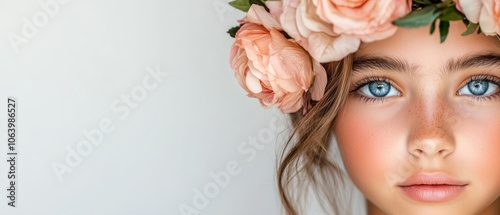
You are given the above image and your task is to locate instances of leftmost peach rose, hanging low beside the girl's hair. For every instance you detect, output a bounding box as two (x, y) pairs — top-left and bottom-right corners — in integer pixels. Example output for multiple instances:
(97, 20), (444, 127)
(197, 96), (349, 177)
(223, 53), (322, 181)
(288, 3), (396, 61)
(230, 5), (326, 113)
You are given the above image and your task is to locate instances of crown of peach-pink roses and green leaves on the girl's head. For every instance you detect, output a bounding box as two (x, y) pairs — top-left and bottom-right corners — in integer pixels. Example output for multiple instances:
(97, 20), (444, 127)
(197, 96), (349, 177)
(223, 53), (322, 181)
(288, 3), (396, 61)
(228, 0), (500, 114)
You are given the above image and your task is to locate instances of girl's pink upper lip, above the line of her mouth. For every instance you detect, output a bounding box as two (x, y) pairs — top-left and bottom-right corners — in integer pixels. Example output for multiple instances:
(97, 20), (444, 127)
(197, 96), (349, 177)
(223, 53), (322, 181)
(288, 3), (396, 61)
(399, 173), (467, 187)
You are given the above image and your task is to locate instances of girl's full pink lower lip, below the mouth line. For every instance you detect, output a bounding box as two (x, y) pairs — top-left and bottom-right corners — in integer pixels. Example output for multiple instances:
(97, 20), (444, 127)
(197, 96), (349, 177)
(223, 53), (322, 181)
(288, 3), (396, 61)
(399, 185), (465, 202)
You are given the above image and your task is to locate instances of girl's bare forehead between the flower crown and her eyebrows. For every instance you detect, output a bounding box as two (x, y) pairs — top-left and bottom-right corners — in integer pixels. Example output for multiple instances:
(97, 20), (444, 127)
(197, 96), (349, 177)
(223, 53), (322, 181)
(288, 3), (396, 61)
(354, 22), (500, 62)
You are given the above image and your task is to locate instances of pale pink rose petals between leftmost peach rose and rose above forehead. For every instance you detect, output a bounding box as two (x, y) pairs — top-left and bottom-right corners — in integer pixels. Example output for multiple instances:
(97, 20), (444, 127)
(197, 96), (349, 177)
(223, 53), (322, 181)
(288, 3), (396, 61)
(280, 0), (360, 63)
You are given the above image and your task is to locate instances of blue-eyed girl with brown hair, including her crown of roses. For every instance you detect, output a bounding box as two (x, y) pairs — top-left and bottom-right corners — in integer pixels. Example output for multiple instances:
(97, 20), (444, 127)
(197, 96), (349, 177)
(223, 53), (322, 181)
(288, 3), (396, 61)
(230, 0), (500, 215)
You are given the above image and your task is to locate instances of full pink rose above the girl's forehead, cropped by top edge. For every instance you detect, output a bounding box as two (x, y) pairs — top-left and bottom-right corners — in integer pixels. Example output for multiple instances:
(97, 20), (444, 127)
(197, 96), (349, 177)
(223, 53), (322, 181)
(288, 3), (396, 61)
(315, 0), (411, 42)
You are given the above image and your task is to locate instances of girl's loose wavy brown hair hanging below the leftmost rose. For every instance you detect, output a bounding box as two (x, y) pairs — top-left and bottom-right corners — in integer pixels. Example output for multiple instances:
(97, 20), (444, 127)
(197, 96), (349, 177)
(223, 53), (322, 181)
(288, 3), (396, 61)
(277, 56), (353, 215)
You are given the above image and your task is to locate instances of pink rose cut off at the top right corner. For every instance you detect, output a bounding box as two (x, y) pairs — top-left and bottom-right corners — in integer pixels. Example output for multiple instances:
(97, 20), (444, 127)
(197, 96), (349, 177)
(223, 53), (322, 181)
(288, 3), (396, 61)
(455, 0), (500, 36)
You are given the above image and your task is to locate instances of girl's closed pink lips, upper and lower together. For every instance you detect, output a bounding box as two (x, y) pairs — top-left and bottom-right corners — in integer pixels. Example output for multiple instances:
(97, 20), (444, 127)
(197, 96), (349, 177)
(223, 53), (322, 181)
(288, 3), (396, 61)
(398, 173), (468, 202)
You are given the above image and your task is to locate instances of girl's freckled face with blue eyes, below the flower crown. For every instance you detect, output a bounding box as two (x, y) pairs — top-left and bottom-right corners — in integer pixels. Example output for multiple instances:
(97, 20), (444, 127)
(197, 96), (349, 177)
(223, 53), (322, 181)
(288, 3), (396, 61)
(334, 22), (500, 215)
